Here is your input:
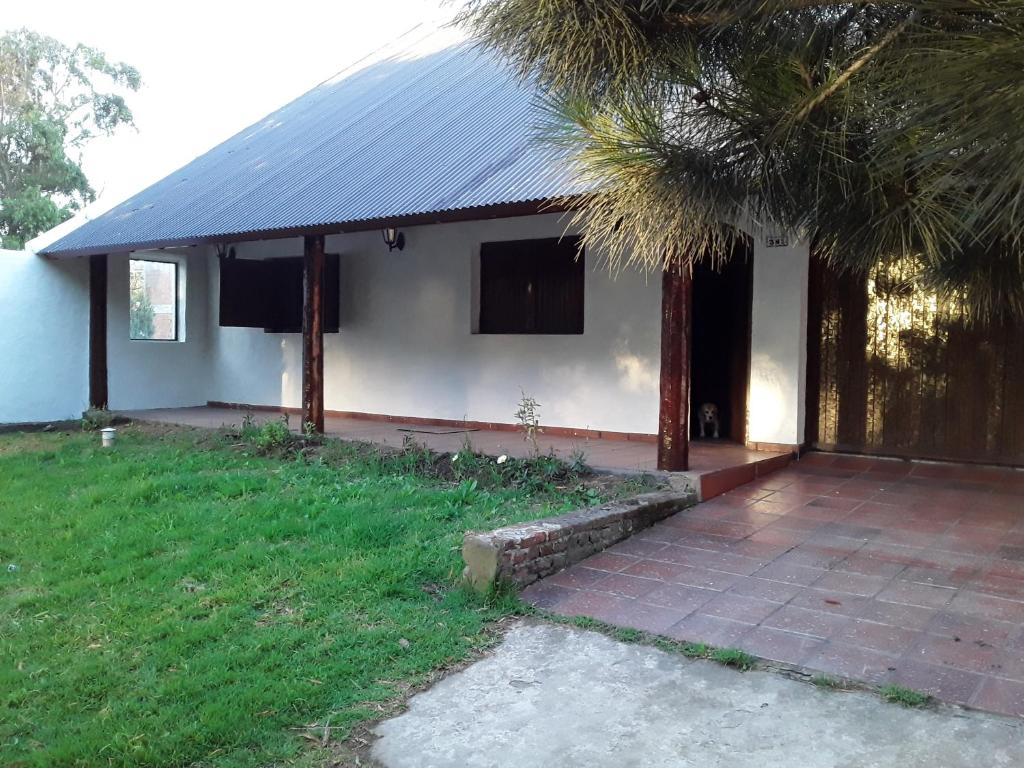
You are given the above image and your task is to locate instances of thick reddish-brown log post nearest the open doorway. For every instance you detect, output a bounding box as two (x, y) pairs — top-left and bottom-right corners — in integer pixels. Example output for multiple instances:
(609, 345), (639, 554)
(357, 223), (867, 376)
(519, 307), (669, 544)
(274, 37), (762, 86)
(657, 266), (693, 472)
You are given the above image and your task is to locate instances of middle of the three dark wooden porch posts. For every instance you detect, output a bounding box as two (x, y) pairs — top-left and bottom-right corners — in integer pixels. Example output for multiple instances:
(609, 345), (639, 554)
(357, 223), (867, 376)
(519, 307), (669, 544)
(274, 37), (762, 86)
(302, 234), (324, 433)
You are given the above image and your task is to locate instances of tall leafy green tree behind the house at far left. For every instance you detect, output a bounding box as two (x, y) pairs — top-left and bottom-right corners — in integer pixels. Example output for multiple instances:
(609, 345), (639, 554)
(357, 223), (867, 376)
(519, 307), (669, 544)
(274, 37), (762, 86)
(0, 30), (140, 248)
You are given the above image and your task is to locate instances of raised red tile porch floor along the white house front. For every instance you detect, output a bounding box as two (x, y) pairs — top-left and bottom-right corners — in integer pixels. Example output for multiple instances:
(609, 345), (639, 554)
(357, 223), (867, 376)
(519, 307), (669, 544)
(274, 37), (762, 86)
(121, 407), (791, 499)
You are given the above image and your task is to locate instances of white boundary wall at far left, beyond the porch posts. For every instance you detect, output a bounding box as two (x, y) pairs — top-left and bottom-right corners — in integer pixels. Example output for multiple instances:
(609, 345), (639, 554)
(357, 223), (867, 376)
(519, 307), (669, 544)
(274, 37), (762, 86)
(0, 251), (89, 424)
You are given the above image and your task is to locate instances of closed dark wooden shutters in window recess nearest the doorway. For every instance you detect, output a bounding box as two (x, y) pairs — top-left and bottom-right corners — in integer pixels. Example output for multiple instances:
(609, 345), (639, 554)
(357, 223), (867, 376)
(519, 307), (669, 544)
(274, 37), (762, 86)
(479, 238), (585, 334)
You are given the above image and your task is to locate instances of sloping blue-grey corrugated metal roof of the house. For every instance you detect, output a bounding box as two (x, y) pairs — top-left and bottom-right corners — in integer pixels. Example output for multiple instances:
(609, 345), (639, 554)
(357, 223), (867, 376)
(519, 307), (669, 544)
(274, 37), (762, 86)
(42, 31), (585, 256)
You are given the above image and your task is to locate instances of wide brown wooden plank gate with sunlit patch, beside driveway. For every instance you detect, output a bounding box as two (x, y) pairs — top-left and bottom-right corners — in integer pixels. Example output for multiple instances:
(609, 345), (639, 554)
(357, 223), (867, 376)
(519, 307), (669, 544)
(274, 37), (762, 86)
(807, 260), (1024, 465)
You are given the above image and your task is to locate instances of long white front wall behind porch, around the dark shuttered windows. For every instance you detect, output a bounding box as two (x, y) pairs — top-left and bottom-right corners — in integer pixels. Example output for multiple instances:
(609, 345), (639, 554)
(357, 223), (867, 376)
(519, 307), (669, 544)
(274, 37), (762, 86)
(210, 214), (660, 432)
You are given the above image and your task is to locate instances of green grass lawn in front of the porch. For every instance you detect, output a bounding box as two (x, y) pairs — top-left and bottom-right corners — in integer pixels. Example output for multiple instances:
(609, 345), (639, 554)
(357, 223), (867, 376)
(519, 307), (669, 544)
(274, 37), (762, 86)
(0, 427), (626, 768)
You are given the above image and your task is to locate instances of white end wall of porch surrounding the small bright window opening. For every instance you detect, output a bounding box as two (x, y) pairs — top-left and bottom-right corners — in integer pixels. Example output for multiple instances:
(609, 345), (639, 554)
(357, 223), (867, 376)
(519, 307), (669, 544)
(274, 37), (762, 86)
(106, 248), (216, 411)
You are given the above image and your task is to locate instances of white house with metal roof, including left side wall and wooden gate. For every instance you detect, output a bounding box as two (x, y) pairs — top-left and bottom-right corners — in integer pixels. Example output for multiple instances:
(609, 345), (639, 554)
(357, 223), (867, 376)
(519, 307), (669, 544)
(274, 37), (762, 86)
(6, 27), (1024, 469)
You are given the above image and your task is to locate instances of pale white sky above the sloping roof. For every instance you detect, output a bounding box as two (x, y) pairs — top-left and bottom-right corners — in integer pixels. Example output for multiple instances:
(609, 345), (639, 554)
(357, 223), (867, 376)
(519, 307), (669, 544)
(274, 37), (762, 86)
(0, 0), (458, 214)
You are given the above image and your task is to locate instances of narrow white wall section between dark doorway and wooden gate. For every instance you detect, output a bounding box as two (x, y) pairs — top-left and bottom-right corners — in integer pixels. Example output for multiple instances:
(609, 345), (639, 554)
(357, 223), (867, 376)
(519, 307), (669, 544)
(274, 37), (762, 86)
(746, 234), (810, 445)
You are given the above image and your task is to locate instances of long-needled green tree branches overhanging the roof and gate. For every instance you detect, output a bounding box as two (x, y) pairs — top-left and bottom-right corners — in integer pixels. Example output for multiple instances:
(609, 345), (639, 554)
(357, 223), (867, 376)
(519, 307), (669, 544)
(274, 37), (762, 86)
(460, 0), (1024, 316)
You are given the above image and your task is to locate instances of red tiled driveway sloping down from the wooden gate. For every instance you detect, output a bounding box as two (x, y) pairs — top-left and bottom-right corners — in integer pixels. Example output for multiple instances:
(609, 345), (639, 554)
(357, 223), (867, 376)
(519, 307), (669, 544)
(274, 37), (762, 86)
(524, 454), (1024, 717)
